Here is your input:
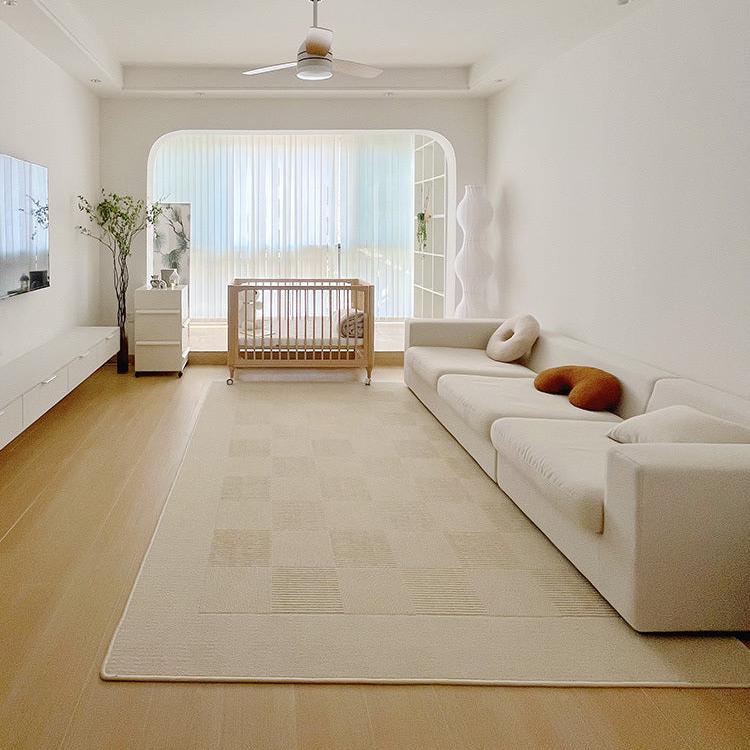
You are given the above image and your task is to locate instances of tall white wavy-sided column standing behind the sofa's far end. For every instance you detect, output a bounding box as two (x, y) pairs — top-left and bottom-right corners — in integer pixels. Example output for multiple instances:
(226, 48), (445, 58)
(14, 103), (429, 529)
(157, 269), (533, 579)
(455, 185), (493, 318)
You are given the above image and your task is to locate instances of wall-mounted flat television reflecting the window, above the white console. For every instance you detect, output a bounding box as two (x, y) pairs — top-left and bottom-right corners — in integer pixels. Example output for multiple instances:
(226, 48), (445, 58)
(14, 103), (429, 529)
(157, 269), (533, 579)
(0, 154), (49, 299)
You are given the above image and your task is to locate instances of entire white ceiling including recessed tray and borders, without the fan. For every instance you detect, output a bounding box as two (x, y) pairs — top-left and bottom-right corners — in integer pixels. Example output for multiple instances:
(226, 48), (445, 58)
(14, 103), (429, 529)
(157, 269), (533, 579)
(0, 0), (652, 96)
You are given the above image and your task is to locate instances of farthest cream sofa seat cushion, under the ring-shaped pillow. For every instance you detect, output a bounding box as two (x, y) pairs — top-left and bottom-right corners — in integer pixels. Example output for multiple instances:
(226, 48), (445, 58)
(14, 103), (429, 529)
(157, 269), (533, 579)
(404, 346), (536, 388)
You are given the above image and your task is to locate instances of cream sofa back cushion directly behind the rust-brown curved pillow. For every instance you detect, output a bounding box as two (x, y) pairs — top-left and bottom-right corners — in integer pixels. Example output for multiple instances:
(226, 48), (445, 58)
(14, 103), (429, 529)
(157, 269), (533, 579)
(523, 331), (671, 419)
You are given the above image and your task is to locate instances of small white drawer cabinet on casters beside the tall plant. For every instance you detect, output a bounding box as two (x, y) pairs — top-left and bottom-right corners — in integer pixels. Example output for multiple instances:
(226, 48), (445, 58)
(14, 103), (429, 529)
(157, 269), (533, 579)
(135, 284), (190, 377)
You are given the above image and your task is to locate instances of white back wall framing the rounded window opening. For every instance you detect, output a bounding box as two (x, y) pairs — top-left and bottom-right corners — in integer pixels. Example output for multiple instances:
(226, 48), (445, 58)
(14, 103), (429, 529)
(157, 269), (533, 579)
(101, 97), (487, 334)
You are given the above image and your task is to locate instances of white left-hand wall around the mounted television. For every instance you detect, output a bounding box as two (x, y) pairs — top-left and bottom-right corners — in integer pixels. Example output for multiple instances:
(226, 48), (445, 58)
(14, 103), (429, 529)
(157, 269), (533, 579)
(0, 22), (99, 364)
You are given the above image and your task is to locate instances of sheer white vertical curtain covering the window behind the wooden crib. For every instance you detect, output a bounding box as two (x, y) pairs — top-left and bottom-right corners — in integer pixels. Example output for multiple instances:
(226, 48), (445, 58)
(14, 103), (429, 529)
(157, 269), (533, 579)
(151, 132), (413, 319)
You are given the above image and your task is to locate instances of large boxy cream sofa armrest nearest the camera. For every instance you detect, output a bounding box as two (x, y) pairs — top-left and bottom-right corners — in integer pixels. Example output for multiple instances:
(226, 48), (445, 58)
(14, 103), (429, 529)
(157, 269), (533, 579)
(604, 443), (750, 631)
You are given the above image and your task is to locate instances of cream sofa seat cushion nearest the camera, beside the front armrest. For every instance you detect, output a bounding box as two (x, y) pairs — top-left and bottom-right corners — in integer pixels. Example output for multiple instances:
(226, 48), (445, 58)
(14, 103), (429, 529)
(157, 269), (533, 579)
(491, 419), (612, 534)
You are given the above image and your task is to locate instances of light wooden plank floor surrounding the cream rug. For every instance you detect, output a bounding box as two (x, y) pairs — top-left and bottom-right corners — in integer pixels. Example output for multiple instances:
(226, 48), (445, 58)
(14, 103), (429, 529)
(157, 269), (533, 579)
(0, 366), (750, 750)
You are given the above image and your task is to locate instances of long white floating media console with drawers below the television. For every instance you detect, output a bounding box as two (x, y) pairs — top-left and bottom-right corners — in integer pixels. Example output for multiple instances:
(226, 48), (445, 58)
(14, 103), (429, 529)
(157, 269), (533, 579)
(0, 326), (120, 448)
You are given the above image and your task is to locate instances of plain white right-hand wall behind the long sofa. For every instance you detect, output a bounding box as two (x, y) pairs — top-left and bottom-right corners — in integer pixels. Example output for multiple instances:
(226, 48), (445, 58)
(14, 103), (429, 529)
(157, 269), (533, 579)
(488, 0), (750, 396)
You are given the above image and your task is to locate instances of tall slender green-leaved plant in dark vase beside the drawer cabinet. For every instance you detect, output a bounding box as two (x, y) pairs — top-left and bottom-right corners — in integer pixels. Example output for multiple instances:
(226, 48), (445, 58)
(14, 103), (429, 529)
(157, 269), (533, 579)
(78, 190), (161, 373)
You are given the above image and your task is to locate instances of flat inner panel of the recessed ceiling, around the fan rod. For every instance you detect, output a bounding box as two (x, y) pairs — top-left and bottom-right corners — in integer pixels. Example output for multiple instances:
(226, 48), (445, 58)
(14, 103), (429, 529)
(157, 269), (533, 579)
(69, 0), (636, 66)
